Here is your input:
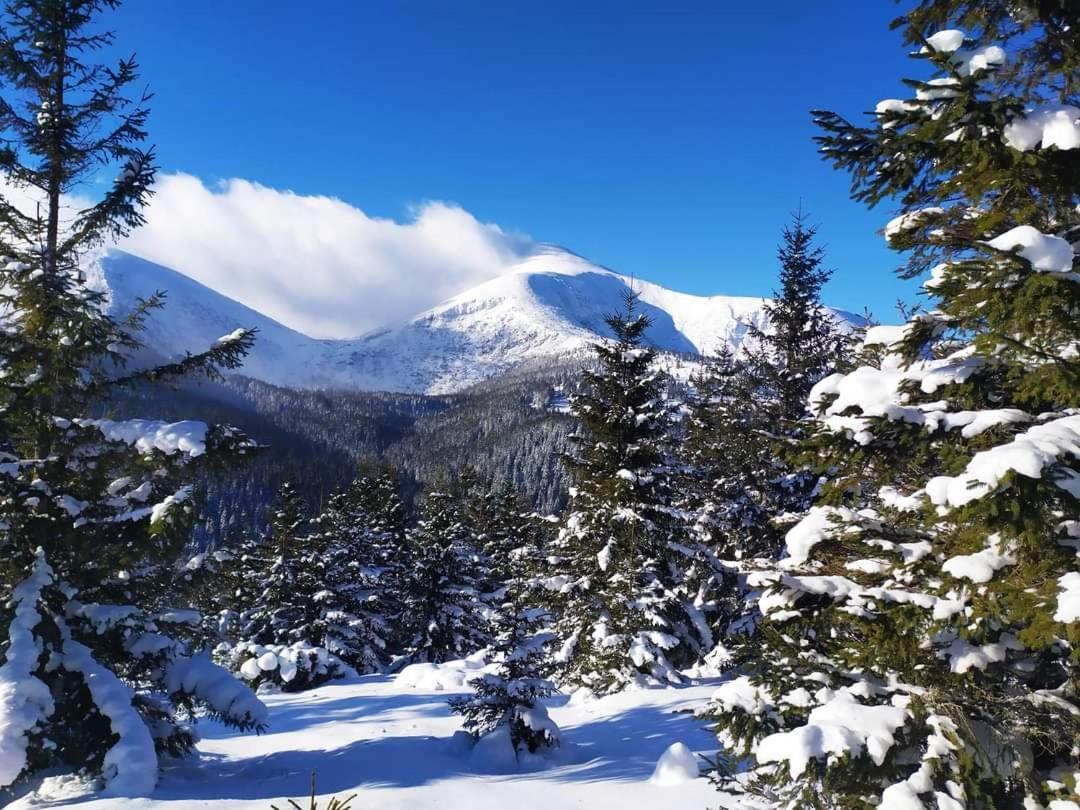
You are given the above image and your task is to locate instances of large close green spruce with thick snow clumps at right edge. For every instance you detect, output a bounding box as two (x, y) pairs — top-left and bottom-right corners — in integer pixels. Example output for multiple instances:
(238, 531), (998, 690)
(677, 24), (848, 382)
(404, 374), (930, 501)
(716, 0), (1080, 810)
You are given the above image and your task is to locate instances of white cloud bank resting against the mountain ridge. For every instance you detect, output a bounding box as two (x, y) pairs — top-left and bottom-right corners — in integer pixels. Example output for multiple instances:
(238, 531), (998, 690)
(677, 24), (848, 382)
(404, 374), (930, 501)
(120, 174), (531, 337)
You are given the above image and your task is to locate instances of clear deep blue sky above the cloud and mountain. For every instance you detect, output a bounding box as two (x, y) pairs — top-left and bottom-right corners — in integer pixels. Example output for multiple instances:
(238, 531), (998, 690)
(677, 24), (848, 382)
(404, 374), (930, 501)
(109, 0), (916, 320)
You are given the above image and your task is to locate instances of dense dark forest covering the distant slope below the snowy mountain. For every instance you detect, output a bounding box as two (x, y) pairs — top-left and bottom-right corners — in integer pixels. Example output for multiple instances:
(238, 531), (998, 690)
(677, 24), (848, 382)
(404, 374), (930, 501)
(102, 360), (581, 545)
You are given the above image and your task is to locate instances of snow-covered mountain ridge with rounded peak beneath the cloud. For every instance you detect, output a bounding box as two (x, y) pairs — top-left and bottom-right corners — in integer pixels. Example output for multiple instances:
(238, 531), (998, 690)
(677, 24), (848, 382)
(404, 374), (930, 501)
(89, 247), (858, 393)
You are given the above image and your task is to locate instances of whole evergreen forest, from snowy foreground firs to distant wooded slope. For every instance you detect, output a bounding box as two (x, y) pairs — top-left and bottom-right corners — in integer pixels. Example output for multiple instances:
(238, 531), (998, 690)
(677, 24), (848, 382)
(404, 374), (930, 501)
(0, 0), (1080, 810)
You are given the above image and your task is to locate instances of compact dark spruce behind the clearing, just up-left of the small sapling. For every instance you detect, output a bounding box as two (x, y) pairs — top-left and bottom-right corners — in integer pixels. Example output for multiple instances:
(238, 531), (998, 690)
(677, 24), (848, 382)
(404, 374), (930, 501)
(399, 488), (490, 663)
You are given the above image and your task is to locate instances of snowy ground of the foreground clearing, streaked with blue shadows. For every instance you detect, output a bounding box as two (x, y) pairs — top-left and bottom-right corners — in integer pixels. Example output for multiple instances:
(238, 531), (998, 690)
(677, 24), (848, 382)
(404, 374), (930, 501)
(10, 676), (744, 810)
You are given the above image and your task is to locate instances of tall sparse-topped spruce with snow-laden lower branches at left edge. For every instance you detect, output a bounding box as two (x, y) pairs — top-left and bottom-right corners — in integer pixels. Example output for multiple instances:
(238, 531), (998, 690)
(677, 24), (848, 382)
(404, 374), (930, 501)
(0, 0), (265, 795)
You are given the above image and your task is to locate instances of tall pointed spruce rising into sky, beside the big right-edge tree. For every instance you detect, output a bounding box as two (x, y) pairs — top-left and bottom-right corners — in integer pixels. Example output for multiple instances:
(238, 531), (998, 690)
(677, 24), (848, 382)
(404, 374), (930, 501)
(679, 217), (850, 663)
